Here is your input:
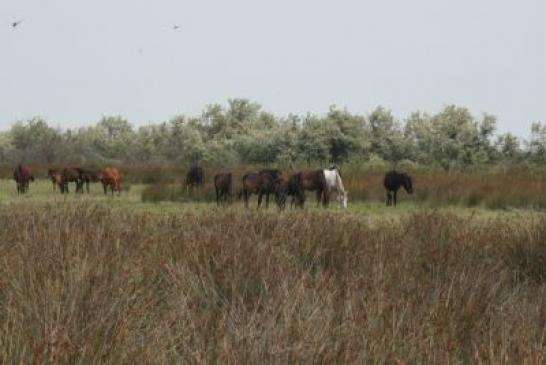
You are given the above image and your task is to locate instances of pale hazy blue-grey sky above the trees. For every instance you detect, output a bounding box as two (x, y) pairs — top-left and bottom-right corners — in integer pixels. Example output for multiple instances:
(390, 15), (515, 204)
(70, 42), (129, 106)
(0, 0), (546, 137)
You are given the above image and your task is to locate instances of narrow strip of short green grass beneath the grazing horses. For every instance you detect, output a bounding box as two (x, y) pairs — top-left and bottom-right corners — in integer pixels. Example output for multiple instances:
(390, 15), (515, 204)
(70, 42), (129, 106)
(0, 179), (544, 228)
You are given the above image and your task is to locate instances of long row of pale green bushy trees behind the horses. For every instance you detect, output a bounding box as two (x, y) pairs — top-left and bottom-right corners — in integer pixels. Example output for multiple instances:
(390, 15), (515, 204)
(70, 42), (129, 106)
(0, 99), (546, 170)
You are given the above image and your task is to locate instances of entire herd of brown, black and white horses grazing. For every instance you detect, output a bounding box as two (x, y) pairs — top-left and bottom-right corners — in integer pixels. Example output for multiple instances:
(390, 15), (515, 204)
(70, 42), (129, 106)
(13, 164), (413, 209)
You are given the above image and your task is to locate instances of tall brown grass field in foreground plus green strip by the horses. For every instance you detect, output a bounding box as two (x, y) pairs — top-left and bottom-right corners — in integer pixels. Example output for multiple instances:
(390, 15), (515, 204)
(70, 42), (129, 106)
(0, 178), (546, 364)
